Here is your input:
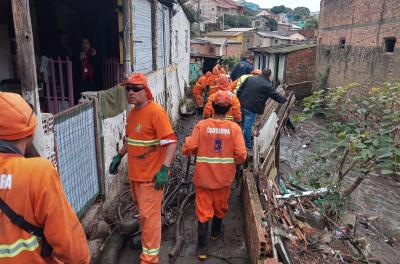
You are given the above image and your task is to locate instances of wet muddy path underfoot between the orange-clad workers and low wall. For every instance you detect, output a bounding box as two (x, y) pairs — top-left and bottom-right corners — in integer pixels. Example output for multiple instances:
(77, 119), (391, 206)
(118, 116), (249, 264)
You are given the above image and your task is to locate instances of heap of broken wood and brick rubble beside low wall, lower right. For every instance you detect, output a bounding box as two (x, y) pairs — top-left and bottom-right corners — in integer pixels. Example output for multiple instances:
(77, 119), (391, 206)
(262, 177), (380, 264)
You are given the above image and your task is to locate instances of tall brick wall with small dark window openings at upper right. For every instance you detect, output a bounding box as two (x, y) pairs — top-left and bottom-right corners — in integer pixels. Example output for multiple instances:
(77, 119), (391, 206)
(317, 0), (400, 89)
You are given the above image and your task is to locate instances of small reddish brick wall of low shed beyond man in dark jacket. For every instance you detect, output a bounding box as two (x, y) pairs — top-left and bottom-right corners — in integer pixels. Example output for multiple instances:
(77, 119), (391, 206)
(286, 47), (316, 99)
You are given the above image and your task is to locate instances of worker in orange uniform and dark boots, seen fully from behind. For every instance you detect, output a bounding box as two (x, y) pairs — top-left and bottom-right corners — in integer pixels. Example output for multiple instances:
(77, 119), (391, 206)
(182, 91), (247, 260)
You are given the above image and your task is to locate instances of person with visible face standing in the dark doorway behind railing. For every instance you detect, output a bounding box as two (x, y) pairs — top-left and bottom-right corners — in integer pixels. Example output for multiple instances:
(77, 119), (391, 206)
(75, 38), (97, 102)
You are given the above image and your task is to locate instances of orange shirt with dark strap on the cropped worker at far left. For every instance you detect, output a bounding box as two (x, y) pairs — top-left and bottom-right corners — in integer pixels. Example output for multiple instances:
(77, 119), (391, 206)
(0, 153), (90, 264)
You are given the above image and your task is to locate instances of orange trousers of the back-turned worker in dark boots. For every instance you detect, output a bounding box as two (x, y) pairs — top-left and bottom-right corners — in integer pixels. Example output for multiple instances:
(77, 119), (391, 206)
(196, 186), (231, 223)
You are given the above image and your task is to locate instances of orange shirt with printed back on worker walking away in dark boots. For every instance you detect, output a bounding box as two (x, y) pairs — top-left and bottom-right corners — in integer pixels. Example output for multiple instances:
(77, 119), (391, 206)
(182, 118), (247, 189)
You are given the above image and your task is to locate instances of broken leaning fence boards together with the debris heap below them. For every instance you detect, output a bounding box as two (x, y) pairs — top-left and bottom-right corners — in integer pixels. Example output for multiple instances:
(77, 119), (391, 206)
(247, 87), (379, 264)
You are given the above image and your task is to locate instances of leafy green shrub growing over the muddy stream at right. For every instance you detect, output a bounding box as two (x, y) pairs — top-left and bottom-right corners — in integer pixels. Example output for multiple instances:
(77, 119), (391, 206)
(295, 83), (400, 217)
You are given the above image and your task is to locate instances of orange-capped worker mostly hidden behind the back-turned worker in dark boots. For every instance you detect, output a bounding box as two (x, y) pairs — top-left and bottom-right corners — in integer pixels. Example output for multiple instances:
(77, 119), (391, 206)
(203, 76), (242, 123)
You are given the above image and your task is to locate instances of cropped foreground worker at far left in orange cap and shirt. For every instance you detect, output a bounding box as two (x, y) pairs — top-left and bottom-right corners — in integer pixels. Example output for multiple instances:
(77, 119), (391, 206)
(0, 92), (90, 264)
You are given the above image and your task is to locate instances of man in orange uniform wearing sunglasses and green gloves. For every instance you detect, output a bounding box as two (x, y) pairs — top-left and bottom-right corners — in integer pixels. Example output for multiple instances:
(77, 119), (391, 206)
(110, 73), (177, 264)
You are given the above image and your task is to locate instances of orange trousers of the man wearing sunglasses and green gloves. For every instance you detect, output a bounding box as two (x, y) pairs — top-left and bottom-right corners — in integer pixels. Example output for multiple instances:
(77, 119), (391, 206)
(131, 181), (163, 264)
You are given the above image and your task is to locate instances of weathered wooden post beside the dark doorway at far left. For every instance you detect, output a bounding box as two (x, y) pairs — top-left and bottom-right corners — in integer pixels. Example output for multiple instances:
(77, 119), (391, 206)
(11, 0), (45, 156)
